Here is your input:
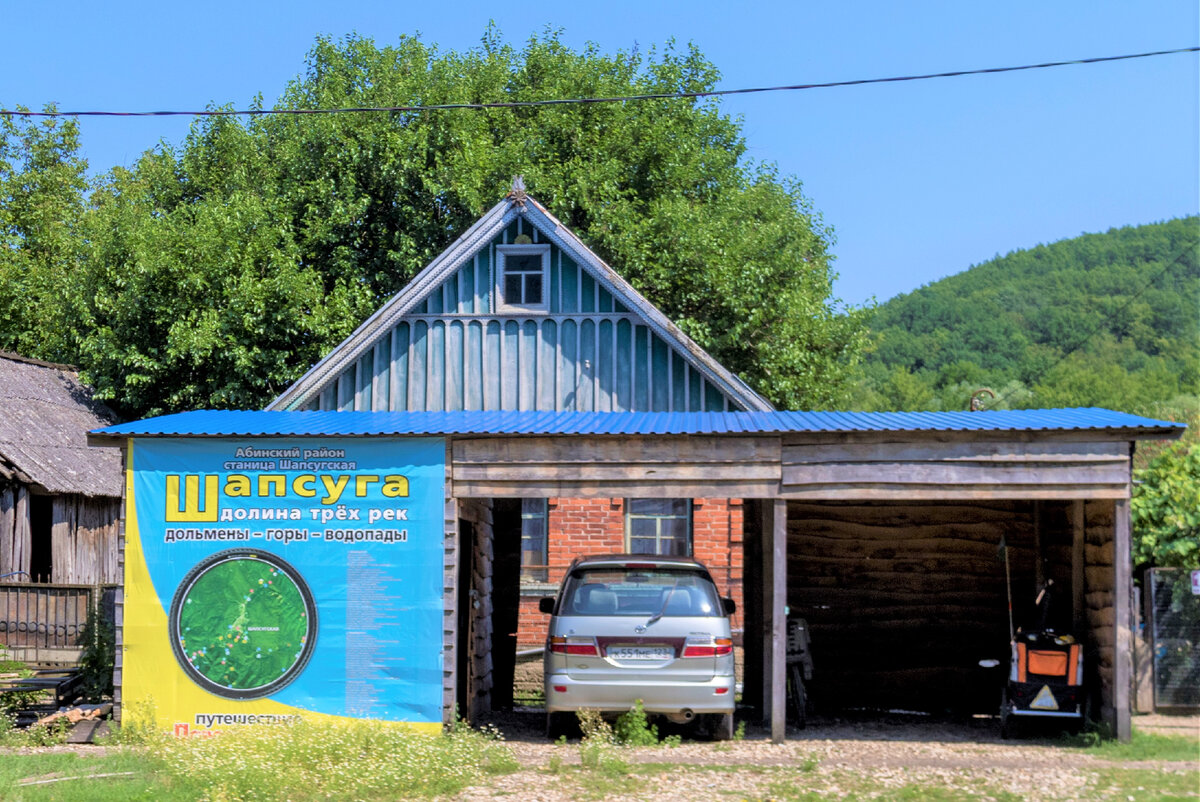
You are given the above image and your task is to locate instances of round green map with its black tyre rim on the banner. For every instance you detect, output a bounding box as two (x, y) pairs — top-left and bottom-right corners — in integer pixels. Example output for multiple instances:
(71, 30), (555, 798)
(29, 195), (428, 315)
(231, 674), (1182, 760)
(170, 549), (317, 699)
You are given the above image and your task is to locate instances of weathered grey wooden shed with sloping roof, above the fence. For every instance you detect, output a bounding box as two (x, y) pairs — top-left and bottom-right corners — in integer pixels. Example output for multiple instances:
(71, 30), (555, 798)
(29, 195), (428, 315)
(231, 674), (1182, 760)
(0, 353), (121, 585)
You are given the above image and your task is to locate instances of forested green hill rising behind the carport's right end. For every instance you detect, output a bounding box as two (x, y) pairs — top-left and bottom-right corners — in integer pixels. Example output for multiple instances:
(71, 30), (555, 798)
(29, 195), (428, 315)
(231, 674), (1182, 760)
(854, 217), (1200, 417)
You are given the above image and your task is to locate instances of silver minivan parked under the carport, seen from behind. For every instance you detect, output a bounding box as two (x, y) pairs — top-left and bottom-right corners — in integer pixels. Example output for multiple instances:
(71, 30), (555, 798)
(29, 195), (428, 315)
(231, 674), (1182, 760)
(539, 555), (734, 738)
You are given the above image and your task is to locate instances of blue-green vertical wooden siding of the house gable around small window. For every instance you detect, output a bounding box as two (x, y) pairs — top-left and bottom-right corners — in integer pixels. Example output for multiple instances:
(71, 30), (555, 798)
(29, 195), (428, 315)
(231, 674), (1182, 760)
(304, 219), (743, 412)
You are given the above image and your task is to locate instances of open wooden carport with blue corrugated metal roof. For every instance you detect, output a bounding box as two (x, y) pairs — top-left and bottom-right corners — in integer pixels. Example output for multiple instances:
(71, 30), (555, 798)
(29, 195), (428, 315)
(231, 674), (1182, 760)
(94, 409), (1182, 741)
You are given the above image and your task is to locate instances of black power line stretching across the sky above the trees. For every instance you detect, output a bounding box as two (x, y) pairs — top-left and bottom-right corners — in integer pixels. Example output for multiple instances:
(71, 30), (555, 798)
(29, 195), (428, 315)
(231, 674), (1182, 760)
(0, 47), (1200, 116)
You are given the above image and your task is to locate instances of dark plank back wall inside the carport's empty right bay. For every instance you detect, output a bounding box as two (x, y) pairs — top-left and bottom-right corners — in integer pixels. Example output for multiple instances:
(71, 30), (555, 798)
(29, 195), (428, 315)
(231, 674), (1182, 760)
(787, 501), (1036, 711)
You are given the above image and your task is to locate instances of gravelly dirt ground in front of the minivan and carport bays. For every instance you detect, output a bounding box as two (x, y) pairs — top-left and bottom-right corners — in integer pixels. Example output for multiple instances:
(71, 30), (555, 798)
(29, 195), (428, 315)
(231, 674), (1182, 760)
(460, 711), (1200, 802)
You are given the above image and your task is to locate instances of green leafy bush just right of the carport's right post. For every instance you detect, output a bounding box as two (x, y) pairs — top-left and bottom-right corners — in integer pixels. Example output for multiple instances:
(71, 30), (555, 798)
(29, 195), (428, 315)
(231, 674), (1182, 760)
(1130, 443), (1200, 568)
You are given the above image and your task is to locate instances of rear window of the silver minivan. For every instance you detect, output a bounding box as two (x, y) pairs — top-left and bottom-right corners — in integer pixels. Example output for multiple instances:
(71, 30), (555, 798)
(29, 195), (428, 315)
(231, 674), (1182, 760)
(558, 567), (725, 618)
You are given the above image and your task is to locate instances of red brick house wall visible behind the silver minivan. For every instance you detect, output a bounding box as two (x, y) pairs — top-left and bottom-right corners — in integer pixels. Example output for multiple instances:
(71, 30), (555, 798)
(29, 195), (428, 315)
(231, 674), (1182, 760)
(517, 498), (744, 650)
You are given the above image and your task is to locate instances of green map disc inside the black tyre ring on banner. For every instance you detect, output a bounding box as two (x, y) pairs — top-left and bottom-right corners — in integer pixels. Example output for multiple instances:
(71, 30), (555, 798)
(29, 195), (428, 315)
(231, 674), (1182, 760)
(176, 556), (311, 690)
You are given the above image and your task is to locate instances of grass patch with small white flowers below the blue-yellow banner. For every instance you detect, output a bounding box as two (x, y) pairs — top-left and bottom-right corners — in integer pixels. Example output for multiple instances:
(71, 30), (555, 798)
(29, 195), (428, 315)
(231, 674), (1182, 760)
(0, 722), (518, 802)
